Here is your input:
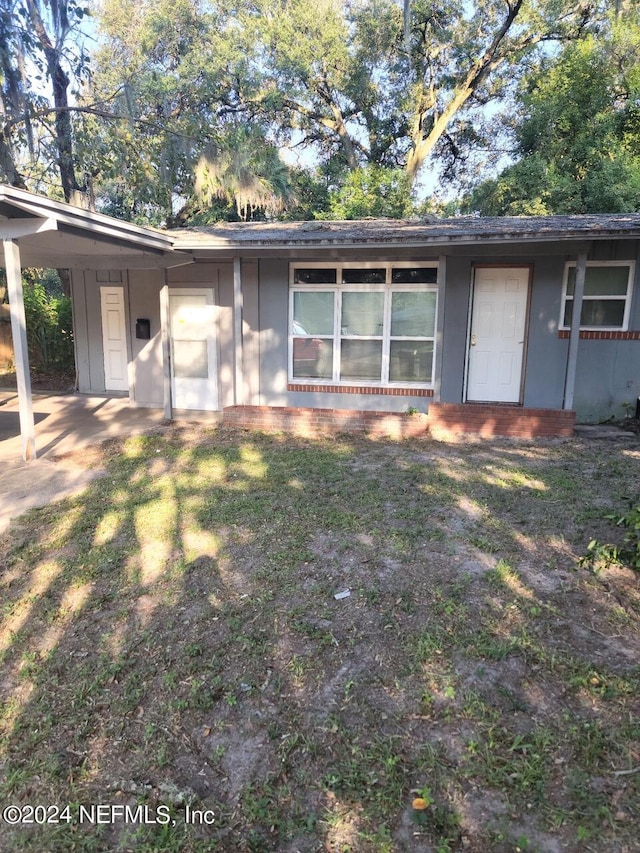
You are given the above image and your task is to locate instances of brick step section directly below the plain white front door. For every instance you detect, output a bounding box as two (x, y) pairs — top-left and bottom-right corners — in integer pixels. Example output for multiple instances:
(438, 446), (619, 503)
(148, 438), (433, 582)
(428, 403), (576, 440)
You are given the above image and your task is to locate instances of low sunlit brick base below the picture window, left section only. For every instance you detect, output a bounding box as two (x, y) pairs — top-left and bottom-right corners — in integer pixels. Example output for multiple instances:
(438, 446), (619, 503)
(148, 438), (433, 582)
(222, 406), (427, 438)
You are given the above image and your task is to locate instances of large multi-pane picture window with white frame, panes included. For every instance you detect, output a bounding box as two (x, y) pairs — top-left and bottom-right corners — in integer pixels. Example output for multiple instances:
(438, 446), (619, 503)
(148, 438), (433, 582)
(289, 263), (438, 386)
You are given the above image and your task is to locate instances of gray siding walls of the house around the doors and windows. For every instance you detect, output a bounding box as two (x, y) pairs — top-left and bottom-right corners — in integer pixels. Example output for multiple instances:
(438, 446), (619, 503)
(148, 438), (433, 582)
(73, 241), (640, 422)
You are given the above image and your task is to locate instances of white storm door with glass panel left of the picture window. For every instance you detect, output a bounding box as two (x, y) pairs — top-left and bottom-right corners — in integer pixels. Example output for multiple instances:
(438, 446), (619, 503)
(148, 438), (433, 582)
(169, 289), (218, 411)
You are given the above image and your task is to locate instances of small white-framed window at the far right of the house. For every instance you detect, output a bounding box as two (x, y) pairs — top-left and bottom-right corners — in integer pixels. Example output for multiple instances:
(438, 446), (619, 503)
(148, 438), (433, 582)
(560, 261), (635, 331)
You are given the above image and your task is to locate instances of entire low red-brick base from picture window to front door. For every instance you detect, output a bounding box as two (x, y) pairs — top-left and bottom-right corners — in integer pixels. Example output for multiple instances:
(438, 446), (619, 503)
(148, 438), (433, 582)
(222, 402), (576, 440)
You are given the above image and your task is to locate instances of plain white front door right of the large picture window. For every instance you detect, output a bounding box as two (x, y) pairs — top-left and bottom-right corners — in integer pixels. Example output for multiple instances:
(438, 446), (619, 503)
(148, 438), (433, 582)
(467, 267), (529, 403)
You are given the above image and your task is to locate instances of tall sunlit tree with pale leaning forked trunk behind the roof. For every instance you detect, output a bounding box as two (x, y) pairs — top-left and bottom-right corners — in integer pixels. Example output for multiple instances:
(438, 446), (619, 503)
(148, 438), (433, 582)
(240, 0), (598, 190)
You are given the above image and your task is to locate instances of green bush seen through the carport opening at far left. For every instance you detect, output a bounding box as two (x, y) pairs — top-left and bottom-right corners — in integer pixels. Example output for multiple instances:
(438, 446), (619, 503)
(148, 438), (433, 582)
(23, 277), (74, 371)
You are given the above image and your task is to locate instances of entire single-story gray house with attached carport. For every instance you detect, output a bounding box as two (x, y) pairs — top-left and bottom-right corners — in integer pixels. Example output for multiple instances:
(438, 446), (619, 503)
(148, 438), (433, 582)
(0, 182), (640, 455)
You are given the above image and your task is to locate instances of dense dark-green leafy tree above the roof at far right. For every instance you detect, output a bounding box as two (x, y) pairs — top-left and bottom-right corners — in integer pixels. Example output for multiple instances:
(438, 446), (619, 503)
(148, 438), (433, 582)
(466, 15), (640, 215)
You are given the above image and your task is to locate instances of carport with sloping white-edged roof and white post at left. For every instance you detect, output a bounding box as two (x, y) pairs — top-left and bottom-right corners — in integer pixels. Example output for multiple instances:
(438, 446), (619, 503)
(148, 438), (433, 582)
(0, 186), (186, 462)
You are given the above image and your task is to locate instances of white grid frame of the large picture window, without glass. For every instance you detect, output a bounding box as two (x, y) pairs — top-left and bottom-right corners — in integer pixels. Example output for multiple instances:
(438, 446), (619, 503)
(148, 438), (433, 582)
(287, 260), (440, 389)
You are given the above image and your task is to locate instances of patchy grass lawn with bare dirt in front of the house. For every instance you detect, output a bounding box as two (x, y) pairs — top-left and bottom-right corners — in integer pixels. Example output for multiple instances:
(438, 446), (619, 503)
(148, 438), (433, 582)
(0, 427), (640, 853)
